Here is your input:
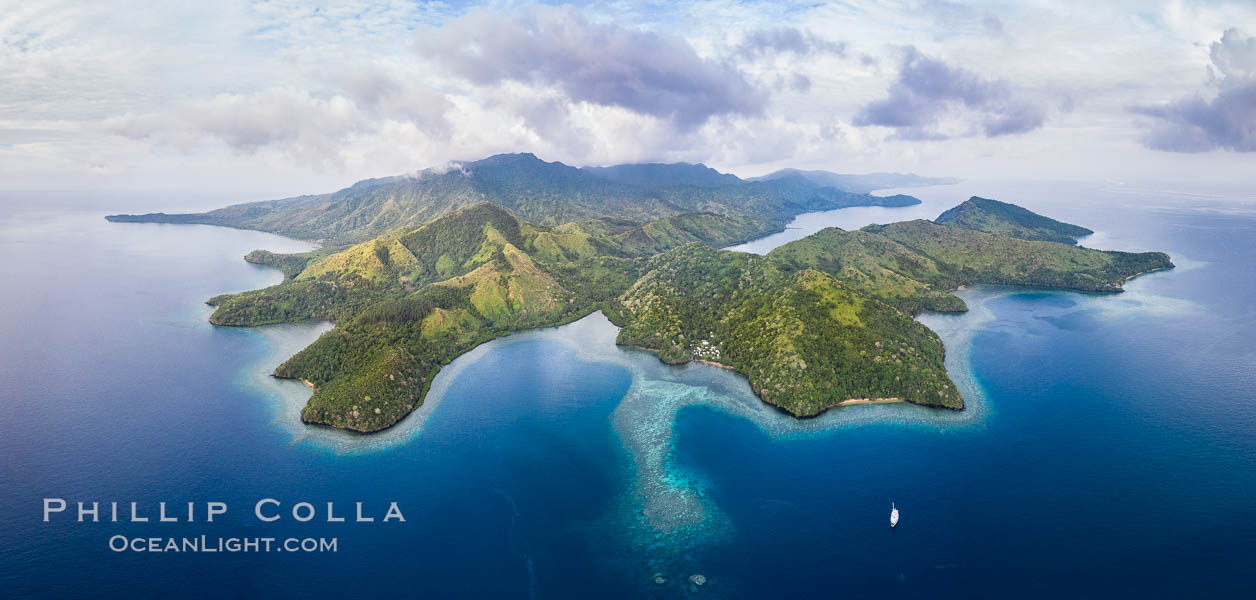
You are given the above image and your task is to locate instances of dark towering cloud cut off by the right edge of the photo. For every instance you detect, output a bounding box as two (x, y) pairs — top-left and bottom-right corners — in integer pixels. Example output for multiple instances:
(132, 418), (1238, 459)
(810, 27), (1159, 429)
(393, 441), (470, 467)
(1130, 28), (1256, 152)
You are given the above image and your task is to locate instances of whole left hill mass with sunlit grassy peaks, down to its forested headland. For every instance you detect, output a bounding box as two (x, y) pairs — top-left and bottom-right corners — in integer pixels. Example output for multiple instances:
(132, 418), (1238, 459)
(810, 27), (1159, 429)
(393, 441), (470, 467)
(211, 203), (602, 432)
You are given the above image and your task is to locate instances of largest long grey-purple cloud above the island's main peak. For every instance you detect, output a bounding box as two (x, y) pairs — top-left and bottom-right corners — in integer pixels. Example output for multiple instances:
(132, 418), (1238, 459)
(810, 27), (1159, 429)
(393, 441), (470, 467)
(414, 6), (767, 129)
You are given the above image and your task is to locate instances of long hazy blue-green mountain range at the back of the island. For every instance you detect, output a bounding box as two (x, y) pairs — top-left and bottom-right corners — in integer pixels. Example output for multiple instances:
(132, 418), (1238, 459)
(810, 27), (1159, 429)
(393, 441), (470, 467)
(107, 154), (919, 244)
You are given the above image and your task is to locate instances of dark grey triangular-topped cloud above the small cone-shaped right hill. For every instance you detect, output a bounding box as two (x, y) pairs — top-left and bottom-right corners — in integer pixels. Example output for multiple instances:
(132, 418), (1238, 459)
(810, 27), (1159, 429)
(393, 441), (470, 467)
(854, 46), (1046, 139)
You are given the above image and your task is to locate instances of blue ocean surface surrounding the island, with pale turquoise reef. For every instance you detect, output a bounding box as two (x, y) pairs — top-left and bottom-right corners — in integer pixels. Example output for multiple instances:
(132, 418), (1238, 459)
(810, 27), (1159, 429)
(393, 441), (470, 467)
(0, 182), (1256, 599)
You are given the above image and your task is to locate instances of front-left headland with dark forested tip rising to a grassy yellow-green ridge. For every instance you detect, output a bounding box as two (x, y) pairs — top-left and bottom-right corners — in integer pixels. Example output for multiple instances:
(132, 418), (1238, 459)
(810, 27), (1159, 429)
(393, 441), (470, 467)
(285, 241), (592, 432)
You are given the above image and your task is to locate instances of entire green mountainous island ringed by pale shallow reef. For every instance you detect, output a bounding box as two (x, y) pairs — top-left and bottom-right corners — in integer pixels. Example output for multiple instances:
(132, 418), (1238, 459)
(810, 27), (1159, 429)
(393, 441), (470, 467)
(109, 154), (1173, 432)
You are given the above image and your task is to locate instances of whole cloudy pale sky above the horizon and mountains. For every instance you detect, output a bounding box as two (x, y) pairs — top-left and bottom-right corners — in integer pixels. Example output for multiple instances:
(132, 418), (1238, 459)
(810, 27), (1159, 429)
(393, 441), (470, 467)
(0, 0), (1256, 200)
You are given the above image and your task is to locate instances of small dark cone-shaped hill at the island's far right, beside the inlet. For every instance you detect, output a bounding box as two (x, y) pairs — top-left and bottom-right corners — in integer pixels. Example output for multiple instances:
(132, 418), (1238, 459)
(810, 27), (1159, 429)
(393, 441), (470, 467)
(933, 196), (1094, 244)
